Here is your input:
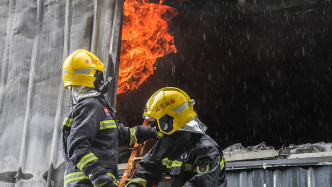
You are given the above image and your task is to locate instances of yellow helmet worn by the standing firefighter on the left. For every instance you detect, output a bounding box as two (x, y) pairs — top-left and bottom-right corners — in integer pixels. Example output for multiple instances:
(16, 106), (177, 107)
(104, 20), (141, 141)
(62, 49), (104, 89)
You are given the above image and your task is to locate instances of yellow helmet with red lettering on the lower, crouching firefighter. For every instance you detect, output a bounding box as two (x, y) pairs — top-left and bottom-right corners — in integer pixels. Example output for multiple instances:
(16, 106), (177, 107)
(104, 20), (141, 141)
(143, 87), (207, 134)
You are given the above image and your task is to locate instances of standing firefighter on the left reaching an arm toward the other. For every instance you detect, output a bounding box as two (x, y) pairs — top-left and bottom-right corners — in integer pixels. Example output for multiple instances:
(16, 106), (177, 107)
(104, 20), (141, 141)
(62, 49), (156, 187)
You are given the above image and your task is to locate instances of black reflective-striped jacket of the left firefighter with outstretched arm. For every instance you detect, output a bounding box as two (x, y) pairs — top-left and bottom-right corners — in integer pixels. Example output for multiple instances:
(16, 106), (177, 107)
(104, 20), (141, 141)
(62, 96), (152, 187)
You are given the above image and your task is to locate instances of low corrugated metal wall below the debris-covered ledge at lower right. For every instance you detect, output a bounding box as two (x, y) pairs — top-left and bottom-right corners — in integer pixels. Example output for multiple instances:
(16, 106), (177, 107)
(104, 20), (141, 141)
(227, 166), (332, 187)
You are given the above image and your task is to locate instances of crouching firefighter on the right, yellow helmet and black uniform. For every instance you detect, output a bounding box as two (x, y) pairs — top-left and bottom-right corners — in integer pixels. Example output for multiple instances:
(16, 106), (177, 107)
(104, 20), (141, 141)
(127, 87), (227, 187)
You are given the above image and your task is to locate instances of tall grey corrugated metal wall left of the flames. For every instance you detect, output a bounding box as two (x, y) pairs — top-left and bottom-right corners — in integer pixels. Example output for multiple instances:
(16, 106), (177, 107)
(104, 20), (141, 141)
(0, 0), (123, 187)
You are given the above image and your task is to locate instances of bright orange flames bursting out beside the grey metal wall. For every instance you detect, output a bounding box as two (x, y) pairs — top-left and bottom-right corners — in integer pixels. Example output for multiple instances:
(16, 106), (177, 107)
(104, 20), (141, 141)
(117, 0), (177, 94)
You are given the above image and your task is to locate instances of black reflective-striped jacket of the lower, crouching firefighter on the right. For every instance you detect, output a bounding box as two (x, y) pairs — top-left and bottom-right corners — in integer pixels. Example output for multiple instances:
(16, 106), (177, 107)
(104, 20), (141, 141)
(128, 131), (227, 187)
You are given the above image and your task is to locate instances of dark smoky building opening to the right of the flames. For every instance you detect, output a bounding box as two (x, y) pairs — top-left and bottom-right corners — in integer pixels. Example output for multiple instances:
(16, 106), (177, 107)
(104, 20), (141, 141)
(116, 6), (332, 149)
